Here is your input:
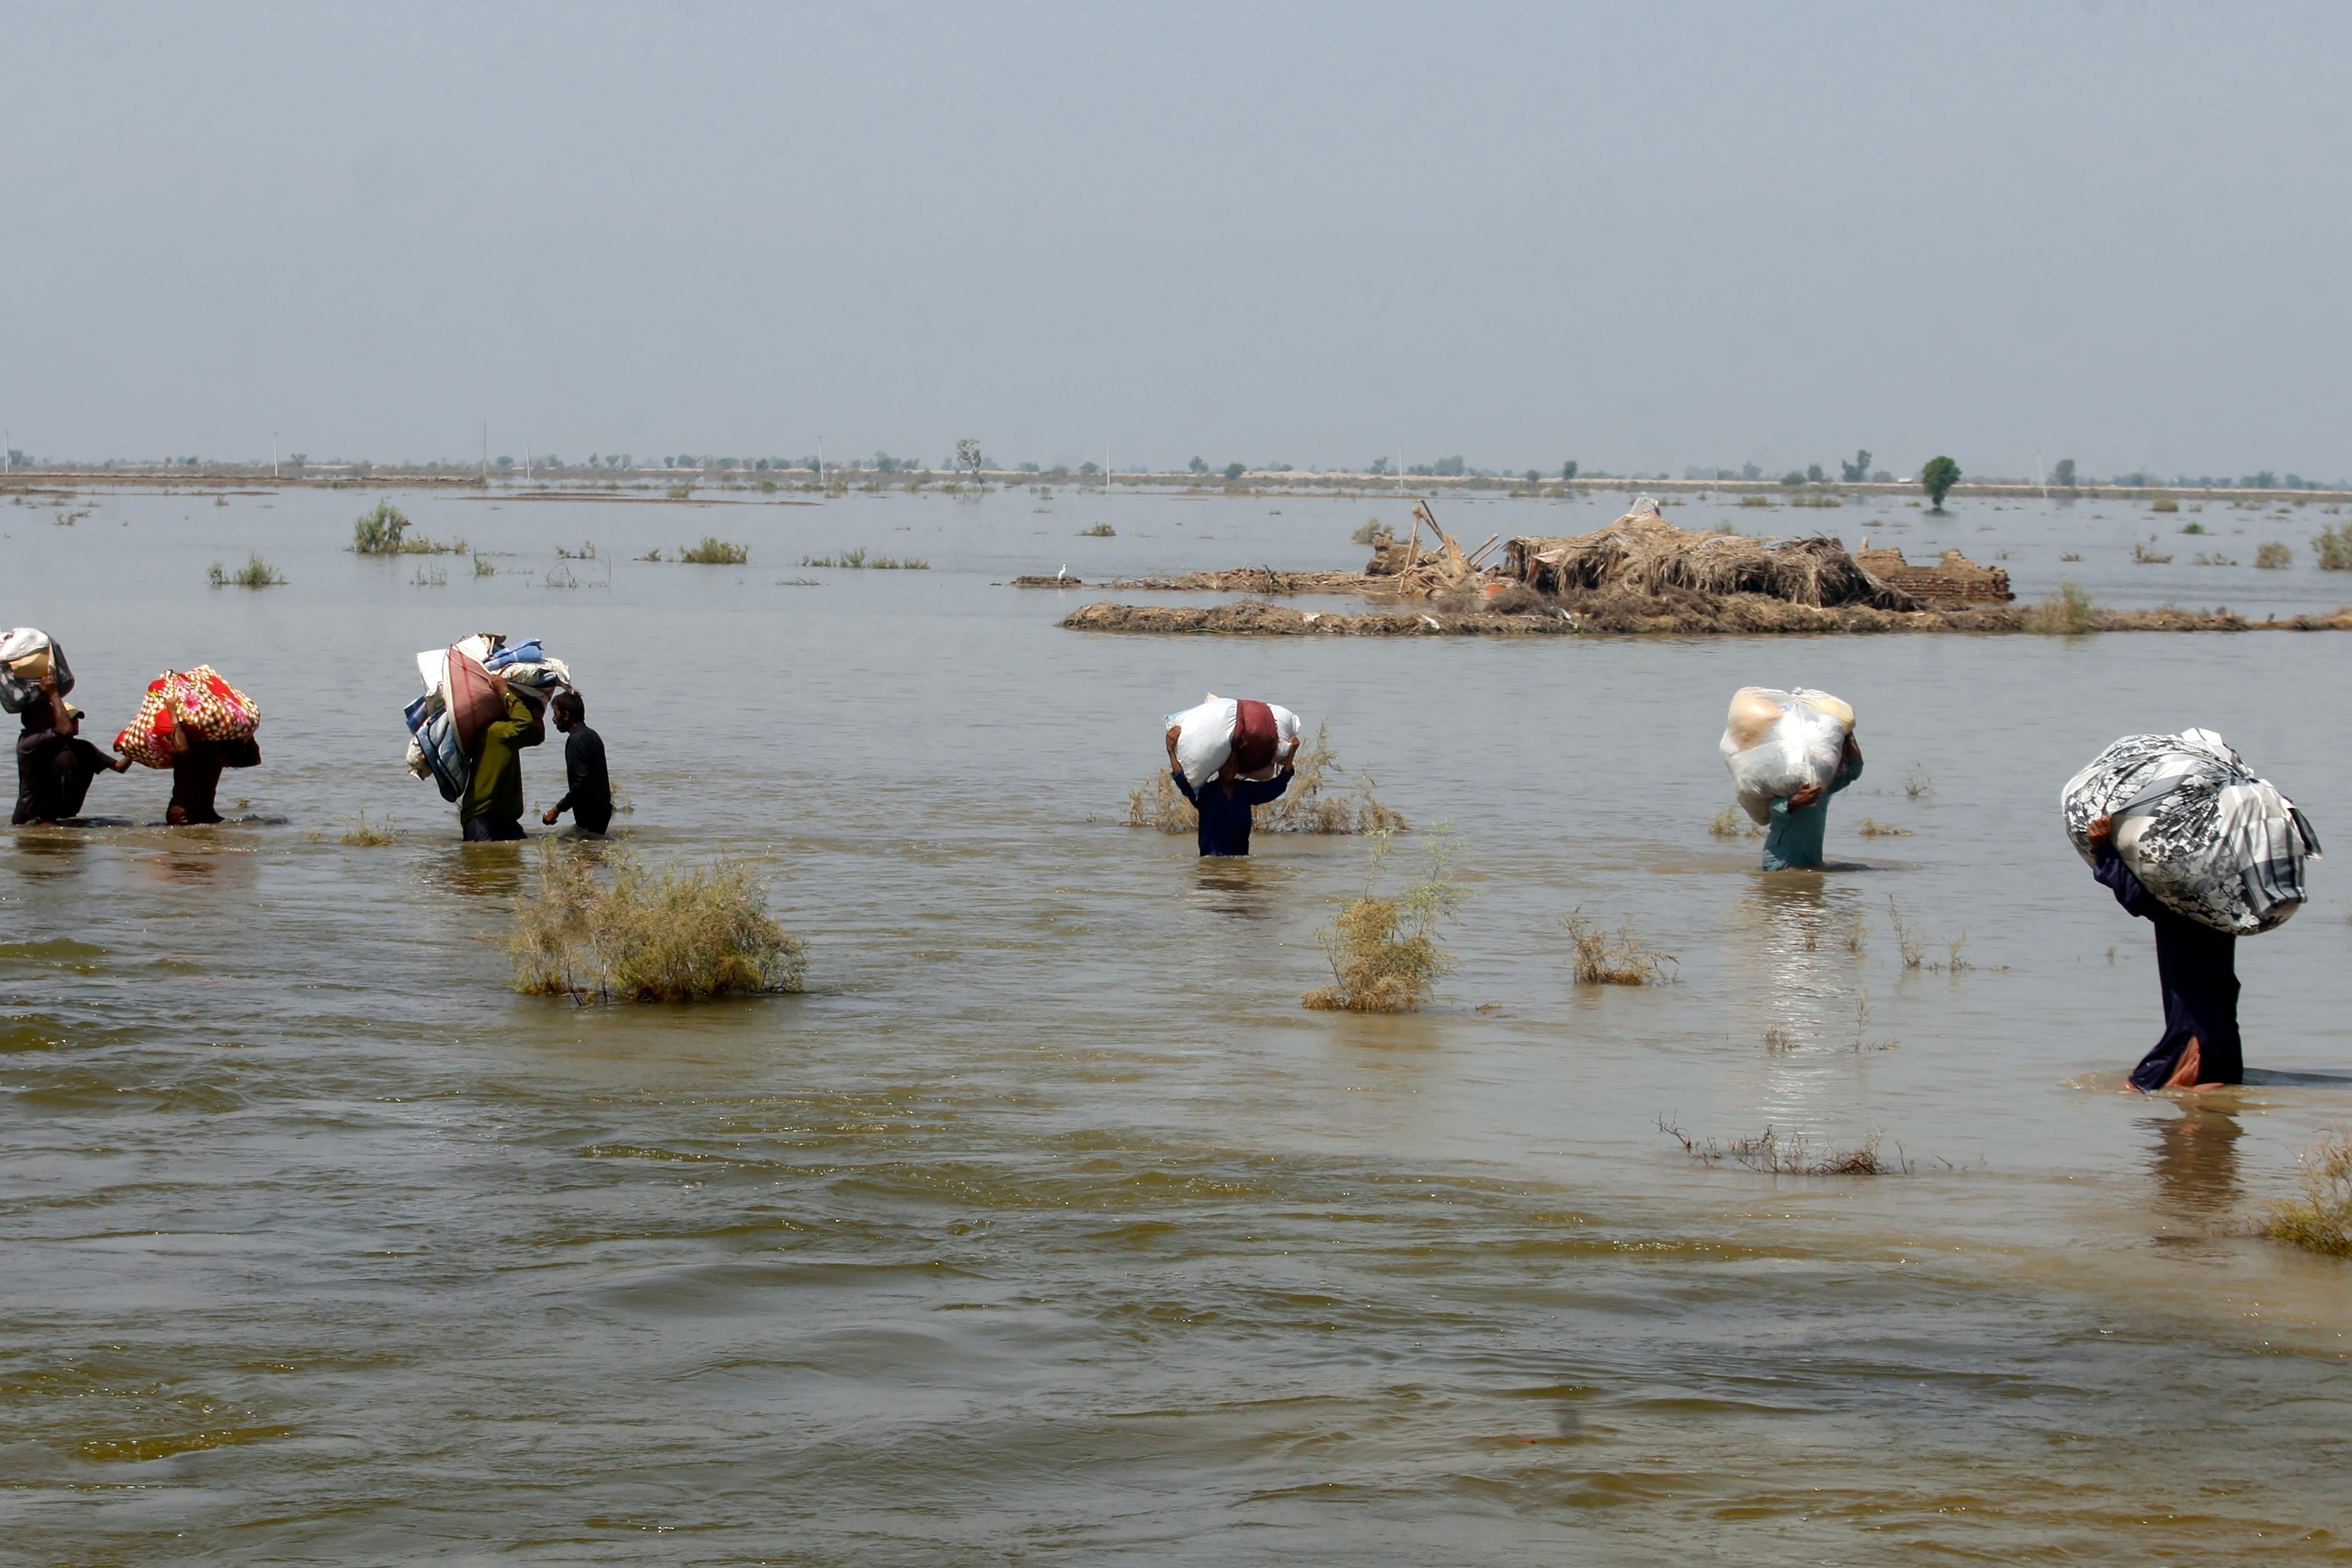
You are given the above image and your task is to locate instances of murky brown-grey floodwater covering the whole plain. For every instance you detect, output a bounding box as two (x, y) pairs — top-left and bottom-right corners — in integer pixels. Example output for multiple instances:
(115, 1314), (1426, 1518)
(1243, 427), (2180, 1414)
(0, 489), (2352, 1563)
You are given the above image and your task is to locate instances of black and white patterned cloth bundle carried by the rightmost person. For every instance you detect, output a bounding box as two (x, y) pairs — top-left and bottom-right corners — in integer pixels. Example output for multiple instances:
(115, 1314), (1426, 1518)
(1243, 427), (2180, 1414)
(2058, 729), (2319, 936)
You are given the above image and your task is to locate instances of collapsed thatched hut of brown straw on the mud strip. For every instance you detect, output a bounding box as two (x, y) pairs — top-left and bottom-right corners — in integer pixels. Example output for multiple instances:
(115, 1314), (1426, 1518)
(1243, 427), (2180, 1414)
(1503, 499), (1919, 609)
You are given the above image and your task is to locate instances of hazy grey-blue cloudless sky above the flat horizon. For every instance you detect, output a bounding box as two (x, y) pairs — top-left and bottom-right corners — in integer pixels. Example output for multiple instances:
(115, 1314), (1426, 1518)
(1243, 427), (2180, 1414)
(0, 0), (2352, 477)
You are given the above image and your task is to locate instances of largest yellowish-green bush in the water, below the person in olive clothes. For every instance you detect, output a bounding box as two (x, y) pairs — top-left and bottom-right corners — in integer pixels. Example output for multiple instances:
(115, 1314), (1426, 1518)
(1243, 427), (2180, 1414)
(508, 839), (809, 1002)
